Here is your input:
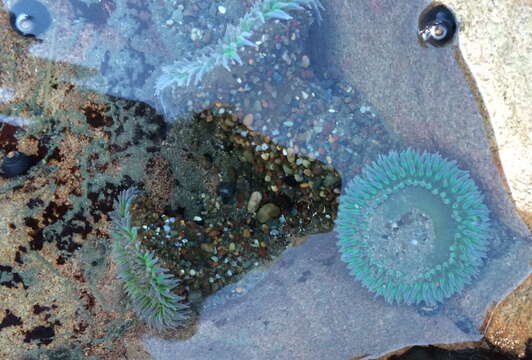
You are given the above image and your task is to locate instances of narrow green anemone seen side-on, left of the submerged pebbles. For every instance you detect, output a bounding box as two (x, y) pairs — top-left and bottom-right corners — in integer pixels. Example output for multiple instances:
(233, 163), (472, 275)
(111, 188), (190, 330)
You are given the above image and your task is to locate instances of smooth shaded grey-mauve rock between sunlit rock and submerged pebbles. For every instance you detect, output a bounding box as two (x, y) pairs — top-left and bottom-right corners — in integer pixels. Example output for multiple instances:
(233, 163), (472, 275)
(317, 0), (530, 239)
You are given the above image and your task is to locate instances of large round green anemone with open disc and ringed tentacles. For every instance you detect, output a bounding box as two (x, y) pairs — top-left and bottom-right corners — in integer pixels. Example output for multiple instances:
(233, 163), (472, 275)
(335, 149), (489, 304)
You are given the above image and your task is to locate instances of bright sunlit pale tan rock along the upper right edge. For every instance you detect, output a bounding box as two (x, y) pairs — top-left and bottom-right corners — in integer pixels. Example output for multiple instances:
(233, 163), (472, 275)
(447, 0), (532, 228)
